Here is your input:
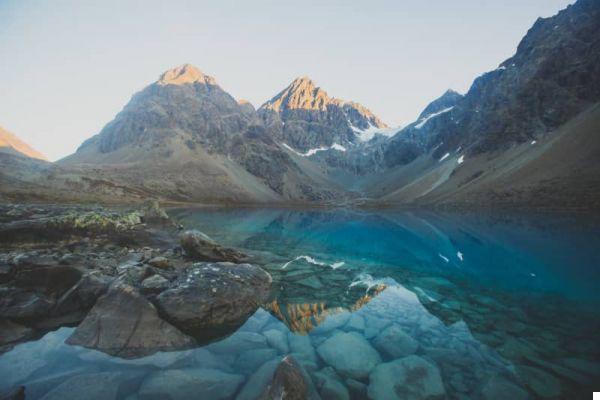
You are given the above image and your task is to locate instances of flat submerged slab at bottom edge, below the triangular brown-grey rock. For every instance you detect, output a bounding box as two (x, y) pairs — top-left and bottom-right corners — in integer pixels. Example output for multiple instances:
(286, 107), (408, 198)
(41, 371), (143, 400)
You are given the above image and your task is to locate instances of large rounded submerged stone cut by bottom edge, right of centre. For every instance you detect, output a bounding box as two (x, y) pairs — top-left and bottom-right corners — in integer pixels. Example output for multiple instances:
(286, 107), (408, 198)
(368, 355), (446, 400)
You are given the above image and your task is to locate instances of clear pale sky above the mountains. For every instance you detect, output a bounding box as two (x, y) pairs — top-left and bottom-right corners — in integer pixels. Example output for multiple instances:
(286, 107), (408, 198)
(0, 0), (573, 160)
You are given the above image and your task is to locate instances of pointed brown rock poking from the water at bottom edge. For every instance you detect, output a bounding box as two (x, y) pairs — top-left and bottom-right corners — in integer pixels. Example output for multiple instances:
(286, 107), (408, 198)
(261, 356), (309, 400)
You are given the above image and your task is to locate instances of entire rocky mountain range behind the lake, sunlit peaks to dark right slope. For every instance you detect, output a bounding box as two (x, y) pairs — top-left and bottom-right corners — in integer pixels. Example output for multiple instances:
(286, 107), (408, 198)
(3, 0), (600, 207)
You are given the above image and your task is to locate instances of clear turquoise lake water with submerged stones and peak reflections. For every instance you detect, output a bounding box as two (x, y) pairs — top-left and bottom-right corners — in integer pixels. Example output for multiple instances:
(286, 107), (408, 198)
(0, 209), (600, 399)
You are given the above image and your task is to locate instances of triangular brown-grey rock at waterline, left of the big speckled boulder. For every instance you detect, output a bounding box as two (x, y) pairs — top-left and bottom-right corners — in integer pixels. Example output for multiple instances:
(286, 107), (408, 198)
(67, 282), (194, 358)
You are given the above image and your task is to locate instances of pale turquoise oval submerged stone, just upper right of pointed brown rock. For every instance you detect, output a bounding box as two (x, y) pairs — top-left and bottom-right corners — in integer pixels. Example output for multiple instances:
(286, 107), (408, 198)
(317, 332), (381, 379)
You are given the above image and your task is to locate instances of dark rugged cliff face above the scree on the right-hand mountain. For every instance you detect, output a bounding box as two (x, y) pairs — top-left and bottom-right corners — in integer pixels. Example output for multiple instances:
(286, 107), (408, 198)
(383, 0), (600, 166)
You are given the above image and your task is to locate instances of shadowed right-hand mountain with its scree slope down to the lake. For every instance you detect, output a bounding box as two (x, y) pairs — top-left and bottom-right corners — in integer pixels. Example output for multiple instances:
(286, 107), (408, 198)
(363, 0), (600, 207)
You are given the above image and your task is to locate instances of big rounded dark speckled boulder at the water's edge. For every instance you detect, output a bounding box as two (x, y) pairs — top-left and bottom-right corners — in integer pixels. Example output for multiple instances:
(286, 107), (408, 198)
(156, 263), (271, 339)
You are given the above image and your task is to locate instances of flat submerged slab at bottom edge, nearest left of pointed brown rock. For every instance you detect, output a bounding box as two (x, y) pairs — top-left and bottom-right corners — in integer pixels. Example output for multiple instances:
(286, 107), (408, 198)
(138, 368), (244, 400)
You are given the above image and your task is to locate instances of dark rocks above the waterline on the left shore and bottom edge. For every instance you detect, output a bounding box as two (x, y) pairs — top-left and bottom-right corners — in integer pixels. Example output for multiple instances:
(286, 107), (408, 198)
(0, 204), (316, 398)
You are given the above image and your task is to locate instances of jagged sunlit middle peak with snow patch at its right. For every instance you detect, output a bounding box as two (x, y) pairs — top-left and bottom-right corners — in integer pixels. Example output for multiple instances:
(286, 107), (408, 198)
(258, 77), (387, 156)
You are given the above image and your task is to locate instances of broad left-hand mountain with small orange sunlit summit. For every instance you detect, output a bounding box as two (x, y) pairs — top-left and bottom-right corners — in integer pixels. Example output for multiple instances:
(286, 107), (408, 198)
(59, 64), (342, 203)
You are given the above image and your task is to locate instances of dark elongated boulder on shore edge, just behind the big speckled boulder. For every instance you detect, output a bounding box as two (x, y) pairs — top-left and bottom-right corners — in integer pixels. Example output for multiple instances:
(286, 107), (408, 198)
(179, 230), (246, 262)
